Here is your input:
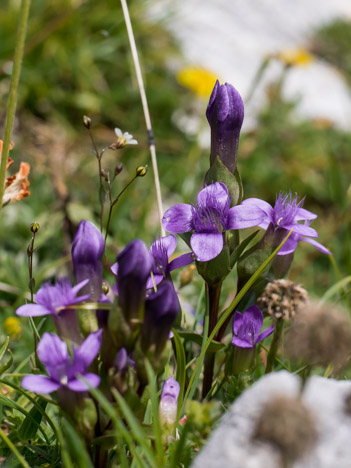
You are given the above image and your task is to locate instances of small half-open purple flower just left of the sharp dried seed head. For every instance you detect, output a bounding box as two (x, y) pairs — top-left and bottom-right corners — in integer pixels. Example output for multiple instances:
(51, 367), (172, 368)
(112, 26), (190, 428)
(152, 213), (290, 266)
(232, 305), (274, 348)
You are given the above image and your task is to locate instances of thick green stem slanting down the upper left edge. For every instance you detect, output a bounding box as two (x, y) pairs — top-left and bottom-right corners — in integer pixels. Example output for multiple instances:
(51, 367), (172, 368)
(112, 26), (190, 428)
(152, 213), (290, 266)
(0, 0), (30, 215)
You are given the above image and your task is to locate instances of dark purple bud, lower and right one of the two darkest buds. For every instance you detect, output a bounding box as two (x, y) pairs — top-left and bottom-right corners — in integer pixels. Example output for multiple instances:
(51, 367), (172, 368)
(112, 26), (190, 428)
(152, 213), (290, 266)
(141, 281), (179, 354)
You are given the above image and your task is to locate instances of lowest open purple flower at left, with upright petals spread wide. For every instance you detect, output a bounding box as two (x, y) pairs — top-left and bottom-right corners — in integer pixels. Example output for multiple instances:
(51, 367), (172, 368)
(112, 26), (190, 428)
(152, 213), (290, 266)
(22, 330), (102, 393)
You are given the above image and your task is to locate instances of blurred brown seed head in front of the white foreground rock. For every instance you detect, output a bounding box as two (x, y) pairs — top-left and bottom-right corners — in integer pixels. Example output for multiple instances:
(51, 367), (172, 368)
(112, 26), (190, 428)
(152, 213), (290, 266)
(253, 397), (317, 461)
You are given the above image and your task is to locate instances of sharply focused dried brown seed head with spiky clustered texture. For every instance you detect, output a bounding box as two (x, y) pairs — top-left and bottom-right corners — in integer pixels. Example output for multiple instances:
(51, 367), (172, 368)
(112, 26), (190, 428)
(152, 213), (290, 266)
(257, 279), (308, 320)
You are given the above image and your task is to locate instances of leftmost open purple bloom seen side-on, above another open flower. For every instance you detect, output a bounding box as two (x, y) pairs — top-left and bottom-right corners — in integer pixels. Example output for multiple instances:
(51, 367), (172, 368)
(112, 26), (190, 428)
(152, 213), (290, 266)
(16, 279), (90, 317)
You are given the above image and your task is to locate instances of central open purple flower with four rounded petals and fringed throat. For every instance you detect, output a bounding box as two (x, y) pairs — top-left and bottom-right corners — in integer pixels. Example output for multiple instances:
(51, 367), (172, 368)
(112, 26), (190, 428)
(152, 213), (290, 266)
(162, 182), (266, 262)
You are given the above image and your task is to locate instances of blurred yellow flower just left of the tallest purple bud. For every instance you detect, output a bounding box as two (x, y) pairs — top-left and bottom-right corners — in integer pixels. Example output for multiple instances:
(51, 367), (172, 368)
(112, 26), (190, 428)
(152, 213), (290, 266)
(177, 67), (217, 97)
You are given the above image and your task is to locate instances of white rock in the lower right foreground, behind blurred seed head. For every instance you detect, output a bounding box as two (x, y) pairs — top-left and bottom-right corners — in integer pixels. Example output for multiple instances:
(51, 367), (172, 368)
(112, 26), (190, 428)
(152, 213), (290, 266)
(192, 371), (351, 468)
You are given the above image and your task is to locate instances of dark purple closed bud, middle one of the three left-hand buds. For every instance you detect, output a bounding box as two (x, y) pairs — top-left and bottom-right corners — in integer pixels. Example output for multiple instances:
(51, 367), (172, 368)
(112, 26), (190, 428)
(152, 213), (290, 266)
(117, 239), (152, 320)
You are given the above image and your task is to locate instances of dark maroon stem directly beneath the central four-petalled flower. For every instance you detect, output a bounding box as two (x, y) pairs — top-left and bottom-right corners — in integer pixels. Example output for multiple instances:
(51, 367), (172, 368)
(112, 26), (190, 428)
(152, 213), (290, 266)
(202, 283), (222, 398)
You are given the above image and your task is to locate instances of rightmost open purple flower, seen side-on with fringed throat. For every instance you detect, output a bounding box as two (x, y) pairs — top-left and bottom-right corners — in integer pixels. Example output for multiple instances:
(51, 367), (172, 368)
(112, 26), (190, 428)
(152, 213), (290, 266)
(242, 193), (330, 255)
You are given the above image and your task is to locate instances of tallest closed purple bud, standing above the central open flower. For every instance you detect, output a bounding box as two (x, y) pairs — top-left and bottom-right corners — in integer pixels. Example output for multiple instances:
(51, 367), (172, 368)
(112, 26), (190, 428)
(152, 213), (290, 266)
(206, 80), (244, 174)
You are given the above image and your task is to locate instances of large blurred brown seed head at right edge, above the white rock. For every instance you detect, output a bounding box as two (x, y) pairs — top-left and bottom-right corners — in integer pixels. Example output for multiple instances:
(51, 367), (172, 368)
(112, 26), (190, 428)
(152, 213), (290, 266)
(285, 302), (351, 370)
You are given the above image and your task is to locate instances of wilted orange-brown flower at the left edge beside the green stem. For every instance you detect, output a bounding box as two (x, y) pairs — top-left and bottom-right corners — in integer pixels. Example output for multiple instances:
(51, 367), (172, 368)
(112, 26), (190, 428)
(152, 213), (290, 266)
(0, 140), (30, 206)
